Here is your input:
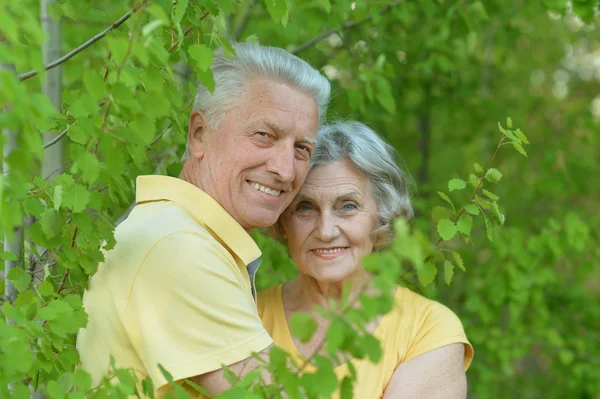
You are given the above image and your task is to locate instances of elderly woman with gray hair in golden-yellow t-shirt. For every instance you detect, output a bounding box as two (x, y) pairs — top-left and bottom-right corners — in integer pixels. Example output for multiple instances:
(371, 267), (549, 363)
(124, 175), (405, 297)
(258, 122), (473, 399)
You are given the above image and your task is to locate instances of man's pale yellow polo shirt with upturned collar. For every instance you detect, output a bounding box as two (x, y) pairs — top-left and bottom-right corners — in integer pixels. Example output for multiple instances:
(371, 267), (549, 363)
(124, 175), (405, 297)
(77, 176), (272, 397)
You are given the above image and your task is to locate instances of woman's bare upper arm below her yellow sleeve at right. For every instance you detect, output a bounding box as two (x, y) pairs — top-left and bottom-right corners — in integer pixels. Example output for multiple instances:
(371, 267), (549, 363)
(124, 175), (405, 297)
(383, 343), (467, 399)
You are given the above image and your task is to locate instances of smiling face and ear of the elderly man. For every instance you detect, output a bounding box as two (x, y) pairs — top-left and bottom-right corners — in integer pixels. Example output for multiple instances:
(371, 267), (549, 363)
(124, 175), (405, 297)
(189, 79), (318, 231)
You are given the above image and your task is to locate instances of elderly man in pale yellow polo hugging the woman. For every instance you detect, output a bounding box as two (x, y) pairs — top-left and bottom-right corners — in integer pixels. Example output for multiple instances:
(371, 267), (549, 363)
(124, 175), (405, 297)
(77, 44), (330, 396)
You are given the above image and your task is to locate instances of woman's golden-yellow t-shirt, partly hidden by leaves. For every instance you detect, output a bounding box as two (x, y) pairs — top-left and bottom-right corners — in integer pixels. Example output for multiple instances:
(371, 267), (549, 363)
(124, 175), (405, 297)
(258, 284), (473, 399)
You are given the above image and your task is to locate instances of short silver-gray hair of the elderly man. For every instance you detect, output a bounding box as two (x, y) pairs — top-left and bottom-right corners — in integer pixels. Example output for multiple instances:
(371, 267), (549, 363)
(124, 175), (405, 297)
(182, 43), (331, 161)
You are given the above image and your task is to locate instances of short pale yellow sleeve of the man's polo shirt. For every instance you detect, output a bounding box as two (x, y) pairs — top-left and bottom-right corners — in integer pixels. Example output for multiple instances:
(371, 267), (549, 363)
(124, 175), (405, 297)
(123, 232), (272, 389)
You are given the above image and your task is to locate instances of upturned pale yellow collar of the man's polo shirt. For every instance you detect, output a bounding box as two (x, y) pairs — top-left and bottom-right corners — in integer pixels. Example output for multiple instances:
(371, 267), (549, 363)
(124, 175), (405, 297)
(136, 175), (261, 265)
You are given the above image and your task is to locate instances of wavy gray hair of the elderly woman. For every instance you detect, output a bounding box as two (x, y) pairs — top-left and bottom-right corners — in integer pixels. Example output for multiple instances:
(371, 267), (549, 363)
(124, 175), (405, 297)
(269, 121), (414, 250)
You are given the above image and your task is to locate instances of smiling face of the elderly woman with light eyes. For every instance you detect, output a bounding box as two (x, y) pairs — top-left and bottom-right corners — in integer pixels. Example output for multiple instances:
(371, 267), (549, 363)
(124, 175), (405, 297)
(281, 160), (379, 282)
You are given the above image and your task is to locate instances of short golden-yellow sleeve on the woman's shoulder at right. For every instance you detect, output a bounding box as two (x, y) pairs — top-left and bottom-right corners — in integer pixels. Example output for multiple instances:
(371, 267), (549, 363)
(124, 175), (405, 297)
(404, 300), (473, 371)
